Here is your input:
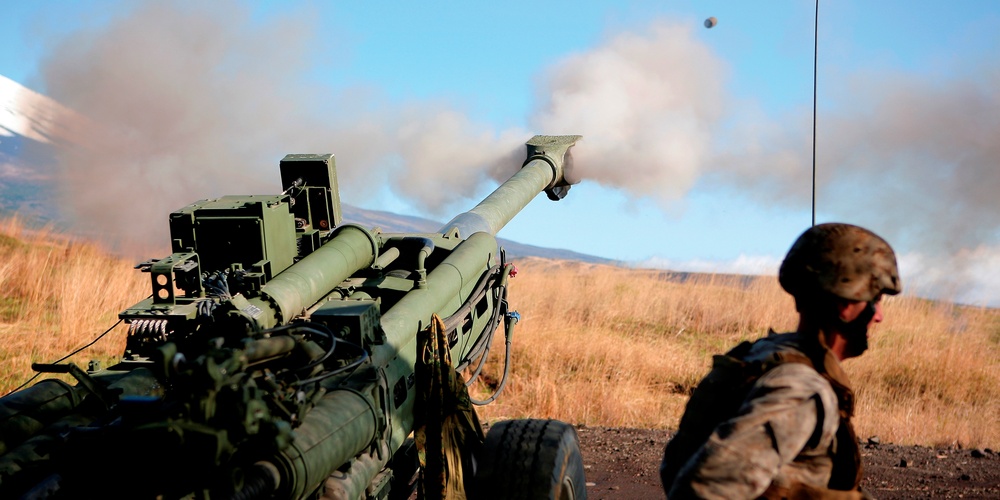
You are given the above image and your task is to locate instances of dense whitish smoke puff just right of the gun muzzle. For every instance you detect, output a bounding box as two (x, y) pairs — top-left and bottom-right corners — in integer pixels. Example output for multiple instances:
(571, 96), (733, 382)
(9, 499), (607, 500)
(532, 22), (727, 200)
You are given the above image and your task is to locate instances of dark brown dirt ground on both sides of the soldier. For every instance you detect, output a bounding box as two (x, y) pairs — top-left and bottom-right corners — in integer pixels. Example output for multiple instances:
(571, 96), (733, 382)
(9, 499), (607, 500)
(576, 427), (1000, 500)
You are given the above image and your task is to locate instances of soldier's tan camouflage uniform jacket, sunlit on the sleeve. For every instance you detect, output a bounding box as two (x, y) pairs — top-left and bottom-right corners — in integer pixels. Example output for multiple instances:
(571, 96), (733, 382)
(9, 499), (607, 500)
(667, 333), (861, 499)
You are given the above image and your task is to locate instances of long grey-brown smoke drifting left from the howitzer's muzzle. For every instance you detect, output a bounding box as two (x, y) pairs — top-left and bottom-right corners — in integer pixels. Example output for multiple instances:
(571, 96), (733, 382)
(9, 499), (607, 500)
(42, 1), (524, 249)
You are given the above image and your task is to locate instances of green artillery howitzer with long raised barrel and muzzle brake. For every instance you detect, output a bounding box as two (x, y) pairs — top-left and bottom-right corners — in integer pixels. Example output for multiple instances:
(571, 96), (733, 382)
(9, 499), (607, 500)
(0, 136), (586, 499)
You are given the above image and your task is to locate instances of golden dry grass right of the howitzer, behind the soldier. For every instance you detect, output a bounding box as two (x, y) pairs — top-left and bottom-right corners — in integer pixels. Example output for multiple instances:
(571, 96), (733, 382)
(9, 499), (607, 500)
(480, 259), (1000, 449)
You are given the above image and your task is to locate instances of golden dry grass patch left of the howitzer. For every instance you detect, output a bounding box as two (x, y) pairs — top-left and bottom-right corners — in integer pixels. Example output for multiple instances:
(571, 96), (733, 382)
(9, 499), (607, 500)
(0, 219), (150, 394)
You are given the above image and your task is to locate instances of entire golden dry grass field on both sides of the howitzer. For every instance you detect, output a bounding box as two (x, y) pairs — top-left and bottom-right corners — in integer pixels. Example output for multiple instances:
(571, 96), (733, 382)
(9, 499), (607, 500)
(0, 220), (1000, 449)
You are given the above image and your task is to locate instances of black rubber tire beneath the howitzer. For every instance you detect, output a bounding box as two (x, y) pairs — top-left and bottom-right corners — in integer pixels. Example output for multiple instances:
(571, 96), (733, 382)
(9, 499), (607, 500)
(475, 419), (587, 500)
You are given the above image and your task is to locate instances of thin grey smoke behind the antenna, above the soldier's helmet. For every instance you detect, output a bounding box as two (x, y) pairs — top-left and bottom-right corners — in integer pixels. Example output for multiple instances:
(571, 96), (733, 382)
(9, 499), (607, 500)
(711, 74), (1000, 253)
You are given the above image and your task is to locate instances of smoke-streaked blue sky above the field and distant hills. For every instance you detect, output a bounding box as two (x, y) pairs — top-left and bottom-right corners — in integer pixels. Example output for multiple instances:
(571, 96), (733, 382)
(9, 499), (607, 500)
(0, 0), (1000, 305)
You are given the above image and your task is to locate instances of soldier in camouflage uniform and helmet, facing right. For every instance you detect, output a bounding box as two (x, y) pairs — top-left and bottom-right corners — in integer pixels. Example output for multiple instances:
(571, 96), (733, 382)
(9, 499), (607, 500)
(660, 224), (902, 500)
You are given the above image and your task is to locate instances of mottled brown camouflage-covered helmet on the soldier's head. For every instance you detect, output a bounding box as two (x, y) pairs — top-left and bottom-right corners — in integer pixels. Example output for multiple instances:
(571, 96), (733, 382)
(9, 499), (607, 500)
(778, 223), (903, 302)
